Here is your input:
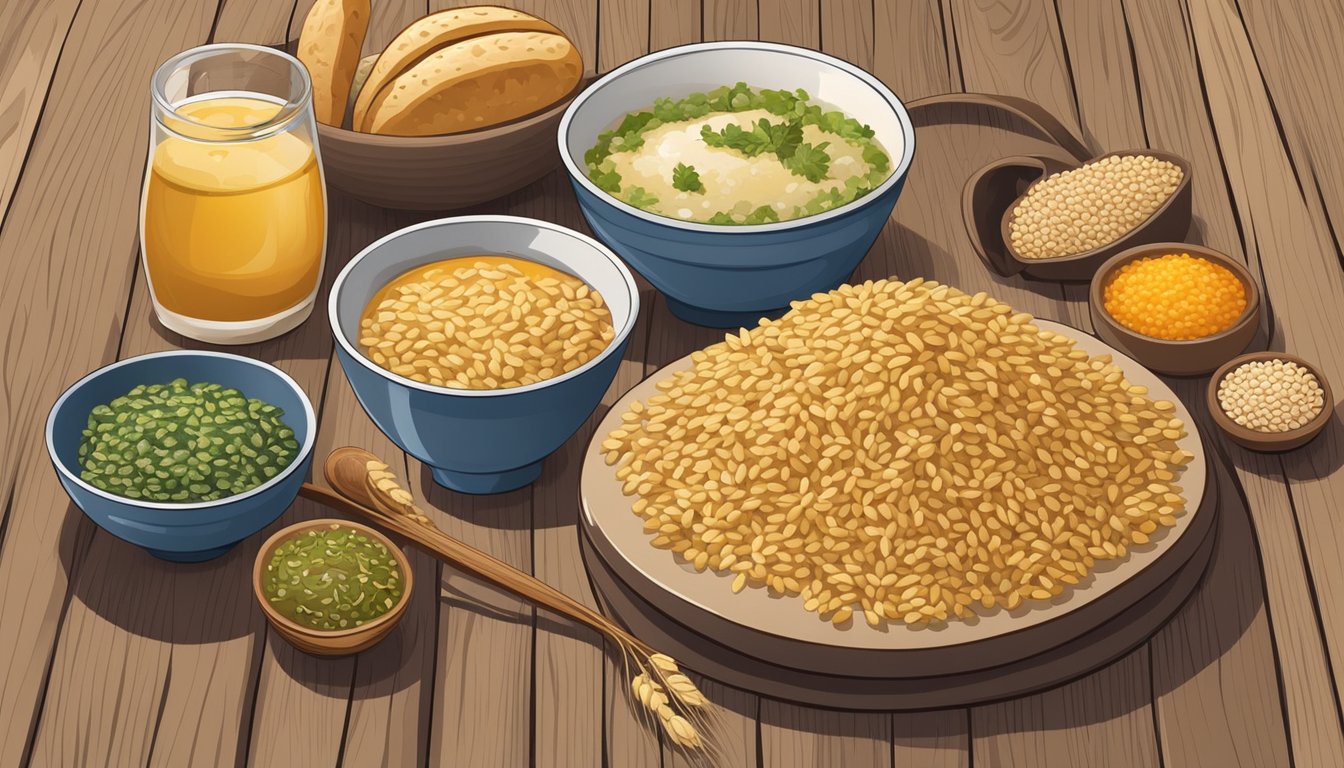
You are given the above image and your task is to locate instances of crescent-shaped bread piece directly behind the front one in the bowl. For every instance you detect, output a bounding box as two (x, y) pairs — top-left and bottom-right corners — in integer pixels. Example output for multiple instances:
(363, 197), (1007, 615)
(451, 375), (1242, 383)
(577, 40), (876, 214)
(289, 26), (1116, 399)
(351, 5), (563, 130)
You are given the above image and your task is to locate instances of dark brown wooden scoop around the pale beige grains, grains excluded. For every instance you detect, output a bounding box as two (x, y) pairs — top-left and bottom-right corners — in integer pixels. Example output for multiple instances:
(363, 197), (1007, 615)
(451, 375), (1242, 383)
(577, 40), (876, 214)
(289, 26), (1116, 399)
(962, 148), (1191, 282)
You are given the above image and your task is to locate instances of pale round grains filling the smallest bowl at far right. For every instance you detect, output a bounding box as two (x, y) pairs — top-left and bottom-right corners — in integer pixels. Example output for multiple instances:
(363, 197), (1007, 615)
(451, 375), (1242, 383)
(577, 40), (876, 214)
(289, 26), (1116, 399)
(1218, 359), (1325, 433)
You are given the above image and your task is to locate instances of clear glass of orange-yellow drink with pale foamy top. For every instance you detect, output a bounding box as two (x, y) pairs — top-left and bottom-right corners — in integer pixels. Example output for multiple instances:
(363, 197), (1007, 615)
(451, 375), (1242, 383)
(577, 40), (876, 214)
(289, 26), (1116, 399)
(140, 43), (327, 344)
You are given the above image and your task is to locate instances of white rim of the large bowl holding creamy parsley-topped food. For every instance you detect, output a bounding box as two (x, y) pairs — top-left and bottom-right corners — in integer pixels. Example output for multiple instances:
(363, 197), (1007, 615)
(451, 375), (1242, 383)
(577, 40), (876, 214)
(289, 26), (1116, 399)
(556, 40), (915, 234)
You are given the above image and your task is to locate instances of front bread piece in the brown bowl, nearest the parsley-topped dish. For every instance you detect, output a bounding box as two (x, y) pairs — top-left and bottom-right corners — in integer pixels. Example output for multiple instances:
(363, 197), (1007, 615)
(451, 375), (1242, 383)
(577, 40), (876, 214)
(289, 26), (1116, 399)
(366, 32), (583, 136)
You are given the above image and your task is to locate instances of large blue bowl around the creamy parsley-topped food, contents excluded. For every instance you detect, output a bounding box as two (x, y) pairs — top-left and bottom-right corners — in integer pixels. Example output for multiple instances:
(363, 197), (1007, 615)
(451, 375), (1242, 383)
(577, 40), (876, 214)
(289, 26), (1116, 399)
(559, 40), (915, 327)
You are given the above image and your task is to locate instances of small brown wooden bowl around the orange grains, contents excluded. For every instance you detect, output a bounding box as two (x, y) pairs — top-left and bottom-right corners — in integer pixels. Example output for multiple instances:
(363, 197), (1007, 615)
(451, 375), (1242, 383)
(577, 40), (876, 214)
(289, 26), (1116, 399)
(1089, 242), (1261, 377)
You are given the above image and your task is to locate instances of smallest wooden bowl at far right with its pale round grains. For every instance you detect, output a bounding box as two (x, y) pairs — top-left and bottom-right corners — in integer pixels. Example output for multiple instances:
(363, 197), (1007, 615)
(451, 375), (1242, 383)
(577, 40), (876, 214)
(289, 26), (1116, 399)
(1208, 351), (1335, 452)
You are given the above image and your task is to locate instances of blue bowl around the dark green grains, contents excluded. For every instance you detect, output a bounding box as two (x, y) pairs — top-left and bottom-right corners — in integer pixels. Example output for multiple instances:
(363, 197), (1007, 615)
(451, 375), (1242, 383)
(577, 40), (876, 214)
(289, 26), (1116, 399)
(47, 351), (317, 562)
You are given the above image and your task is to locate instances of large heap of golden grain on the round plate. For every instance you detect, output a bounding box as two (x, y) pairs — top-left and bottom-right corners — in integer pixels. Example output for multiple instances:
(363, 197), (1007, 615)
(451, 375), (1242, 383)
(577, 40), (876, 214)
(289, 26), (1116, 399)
(602, 280), (1191, 625)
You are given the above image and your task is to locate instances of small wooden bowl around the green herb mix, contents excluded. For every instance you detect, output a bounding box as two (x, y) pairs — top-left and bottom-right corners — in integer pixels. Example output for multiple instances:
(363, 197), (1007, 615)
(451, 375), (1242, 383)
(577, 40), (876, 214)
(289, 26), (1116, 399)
(253, 518), (413, 656)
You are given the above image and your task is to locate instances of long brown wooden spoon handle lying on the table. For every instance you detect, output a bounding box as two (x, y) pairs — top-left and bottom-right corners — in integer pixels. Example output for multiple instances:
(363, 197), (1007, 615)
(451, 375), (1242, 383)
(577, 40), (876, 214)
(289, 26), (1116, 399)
(298, 483), (656, 654)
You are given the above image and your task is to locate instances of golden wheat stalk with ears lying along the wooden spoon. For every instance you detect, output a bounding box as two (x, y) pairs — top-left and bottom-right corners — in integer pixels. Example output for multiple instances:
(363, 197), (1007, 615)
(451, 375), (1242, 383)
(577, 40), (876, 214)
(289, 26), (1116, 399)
(364, 460), (715, 752)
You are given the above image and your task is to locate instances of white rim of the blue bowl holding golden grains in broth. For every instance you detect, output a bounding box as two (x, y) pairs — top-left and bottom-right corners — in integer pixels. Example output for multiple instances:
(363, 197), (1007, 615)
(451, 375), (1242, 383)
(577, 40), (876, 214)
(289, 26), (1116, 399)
(327, 214), (640, 397)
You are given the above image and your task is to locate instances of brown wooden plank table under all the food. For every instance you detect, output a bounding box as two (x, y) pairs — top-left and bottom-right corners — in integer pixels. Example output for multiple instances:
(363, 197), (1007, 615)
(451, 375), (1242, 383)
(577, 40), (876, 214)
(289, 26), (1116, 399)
(0, 0), (1344, 768)
